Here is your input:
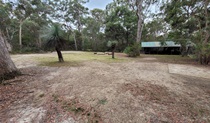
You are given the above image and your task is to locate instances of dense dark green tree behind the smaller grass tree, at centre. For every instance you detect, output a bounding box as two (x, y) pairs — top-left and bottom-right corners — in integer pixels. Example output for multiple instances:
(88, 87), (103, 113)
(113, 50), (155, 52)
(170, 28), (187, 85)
(105, 2), (137, 51)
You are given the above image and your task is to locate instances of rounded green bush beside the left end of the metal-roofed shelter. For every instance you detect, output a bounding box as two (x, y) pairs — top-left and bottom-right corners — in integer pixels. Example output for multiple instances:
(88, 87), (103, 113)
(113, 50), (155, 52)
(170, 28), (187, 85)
(123, 43), (140, 57)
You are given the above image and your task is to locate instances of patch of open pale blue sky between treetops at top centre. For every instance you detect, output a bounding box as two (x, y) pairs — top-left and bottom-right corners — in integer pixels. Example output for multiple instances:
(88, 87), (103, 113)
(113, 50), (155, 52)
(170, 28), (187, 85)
(85, 0), (113, 10)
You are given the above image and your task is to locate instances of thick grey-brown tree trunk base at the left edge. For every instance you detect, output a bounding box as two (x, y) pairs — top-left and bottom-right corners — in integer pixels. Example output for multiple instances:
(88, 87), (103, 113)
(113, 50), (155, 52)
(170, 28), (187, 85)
(0, 31), (20, 83)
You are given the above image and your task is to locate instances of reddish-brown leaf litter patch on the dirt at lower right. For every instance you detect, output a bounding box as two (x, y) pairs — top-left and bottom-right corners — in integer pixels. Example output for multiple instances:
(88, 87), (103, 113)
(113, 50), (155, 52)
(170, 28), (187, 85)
(121, 83), (209, 123)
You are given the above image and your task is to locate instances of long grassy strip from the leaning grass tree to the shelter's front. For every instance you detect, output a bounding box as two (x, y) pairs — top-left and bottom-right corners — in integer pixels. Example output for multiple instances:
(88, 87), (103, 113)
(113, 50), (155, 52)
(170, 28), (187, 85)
(21, 52), (197, 67)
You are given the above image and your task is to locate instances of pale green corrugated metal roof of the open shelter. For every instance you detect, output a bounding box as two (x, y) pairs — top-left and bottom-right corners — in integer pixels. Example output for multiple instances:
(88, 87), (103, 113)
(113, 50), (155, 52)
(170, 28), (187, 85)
(141, 41), (181, 47)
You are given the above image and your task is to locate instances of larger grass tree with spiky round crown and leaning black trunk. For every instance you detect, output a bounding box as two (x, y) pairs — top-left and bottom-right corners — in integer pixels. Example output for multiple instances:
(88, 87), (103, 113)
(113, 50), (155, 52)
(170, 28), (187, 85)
(40, 24), (65, 62)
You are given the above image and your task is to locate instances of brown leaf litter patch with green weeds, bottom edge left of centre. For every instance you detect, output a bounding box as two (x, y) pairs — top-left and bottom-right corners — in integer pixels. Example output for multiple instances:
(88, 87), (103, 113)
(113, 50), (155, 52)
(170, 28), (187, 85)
(43, 94), (102, 123)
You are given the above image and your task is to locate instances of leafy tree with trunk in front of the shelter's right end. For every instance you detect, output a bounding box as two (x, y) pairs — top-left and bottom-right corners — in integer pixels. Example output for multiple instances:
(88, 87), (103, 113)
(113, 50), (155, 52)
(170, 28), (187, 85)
(162, 1), (197, 56)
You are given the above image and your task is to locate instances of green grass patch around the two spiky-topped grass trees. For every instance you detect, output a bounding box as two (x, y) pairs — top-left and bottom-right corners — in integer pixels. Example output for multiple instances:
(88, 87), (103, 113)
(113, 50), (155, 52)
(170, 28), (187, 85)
(35, 52), (128, 67)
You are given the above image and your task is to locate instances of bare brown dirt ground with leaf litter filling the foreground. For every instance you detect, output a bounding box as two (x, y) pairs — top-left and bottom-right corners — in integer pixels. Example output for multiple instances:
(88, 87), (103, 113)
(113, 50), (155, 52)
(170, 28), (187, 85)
(0, 51), (210, 123)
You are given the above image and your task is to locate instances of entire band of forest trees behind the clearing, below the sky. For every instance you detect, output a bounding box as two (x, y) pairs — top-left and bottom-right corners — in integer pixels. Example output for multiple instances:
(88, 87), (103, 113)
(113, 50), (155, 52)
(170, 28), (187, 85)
(0, 0), (210, 63)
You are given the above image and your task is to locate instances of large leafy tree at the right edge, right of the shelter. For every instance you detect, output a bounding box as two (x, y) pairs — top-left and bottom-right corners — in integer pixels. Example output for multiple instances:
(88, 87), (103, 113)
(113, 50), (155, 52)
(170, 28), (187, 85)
(162, 0), (210, 64)
